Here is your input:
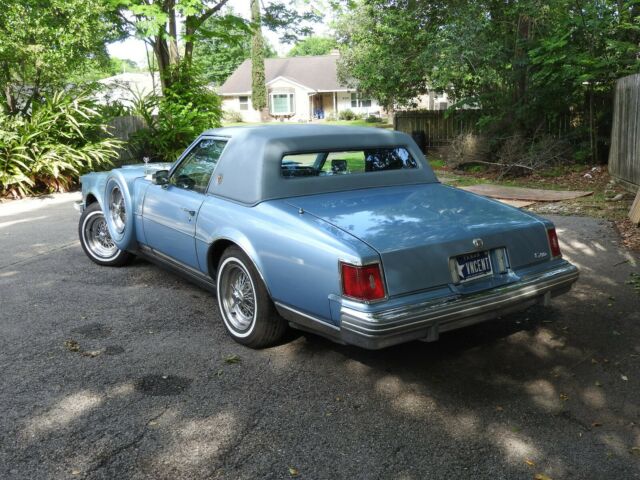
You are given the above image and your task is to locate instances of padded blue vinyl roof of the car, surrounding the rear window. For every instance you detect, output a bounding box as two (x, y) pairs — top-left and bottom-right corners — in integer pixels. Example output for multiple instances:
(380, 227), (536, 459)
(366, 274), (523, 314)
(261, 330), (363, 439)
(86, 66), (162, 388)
(202, 125), (437, 205)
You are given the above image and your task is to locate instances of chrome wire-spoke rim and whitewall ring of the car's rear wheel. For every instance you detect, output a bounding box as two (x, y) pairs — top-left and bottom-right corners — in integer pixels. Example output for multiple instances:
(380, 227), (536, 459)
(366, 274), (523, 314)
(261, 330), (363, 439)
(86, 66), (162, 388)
(220, 262), (256, 332)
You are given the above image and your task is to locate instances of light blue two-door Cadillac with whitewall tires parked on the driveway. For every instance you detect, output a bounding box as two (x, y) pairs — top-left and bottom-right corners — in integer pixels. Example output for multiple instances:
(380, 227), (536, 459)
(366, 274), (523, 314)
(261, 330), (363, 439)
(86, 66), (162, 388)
(79, 125), (578, 349)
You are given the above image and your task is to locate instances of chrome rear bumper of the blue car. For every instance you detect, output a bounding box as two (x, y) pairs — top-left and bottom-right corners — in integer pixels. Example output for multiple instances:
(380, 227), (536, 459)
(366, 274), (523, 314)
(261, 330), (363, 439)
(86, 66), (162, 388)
(279, 262), (578, 349)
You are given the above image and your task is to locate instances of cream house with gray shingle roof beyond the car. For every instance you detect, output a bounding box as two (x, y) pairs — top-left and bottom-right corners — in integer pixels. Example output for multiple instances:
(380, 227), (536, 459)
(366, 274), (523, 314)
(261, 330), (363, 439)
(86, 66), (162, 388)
(218, 53), (381, 122)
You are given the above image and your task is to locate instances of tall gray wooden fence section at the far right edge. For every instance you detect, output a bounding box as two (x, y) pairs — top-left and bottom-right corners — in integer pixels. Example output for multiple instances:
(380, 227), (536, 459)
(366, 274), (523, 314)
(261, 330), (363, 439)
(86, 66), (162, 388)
(609, 74), (640, 188)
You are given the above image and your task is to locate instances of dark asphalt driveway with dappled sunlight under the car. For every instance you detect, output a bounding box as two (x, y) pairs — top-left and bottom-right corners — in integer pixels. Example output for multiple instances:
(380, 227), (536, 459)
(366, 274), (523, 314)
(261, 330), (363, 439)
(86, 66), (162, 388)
(0, 194), (640, 480)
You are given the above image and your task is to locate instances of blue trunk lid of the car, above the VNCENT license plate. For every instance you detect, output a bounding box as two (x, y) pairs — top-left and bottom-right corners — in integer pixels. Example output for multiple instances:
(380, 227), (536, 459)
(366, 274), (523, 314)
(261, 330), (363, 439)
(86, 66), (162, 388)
(288, 183), (549, 295)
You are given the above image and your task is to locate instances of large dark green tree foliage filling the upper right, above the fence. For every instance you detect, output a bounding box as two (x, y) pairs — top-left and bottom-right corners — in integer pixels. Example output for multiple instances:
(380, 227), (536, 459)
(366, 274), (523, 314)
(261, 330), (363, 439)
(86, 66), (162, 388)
(337, 0), (640, 161)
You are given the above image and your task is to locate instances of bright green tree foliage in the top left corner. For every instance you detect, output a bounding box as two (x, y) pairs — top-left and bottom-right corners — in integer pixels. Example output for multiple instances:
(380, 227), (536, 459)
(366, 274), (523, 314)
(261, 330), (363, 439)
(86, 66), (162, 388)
(0, 0), (123, 114)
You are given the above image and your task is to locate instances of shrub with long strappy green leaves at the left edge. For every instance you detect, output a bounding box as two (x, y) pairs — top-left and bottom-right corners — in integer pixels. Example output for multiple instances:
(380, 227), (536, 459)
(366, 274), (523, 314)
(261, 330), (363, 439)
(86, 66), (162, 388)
(0, 91), (123, 197)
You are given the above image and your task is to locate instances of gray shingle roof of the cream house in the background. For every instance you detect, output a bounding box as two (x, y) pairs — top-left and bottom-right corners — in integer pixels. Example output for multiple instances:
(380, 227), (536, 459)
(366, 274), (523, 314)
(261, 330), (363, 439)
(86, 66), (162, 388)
(218, 55), (346, 95)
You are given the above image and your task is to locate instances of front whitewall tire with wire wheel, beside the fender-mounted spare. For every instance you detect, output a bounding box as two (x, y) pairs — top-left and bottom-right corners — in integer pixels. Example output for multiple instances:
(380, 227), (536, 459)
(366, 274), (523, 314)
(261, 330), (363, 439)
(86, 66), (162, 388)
(78, 202), (134, 267)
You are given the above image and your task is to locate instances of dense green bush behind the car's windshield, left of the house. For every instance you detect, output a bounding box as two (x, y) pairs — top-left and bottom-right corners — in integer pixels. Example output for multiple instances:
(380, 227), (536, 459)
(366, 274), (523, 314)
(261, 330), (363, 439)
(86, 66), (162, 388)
(131, 67), (222, 162)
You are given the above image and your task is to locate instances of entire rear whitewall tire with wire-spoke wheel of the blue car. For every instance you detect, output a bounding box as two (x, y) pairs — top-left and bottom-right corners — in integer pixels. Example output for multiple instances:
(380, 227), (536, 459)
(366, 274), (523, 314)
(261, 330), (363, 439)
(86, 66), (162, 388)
(216, 247), (287, 348)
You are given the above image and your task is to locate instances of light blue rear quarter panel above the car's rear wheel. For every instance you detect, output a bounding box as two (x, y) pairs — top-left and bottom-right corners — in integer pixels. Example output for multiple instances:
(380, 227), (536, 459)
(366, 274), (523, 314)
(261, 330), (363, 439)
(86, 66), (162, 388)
(196, 196), (379, 322)
